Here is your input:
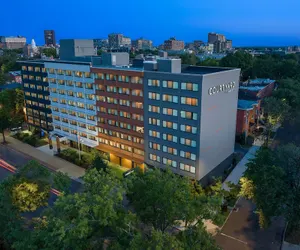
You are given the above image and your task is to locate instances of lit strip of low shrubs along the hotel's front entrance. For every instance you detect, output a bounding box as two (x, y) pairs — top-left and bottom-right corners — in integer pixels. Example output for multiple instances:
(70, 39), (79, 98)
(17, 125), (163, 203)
(56, 148), (128, 179)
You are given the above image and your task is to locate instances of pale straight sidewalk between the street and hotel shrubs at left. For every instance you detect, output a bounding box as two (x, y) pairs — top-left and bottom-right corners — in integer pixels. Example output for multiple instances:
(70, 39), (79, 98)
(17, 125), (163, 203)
(1, 136), (85, 179)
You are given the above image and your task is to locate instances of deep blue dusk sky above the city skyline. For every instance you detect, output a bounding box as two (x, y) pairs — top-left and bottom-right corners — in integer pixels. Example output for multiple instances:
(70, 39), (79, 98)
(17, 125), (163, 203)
(0, 0), (300, 46)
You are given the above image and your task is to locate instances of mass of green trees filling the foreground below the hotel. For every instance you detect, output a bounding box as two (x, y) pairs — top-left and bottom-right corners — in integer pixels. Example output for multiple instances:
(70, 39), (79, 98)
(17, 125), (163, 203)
(0, 159), (231, 250)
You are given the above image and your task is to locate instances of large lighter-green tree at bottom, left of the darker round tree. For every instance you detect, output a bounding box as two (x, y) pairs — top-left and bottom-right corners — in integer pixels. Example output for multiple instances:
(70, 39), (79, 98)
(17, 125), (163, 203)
(41, 169), (124, 250)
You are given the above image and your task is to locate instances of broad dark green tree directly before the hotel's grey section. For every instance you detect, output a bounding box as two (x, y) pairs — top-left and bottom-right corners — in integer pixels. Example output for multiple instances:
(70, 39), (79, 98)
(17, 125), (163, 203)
(128, 169), (220, 232)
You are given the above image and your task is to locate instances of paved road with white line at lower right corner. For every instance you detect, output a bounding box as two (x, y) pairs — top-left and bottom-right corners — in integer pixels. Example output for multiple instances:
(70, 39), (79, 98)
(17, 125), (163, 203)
(215, 198), (285, 250)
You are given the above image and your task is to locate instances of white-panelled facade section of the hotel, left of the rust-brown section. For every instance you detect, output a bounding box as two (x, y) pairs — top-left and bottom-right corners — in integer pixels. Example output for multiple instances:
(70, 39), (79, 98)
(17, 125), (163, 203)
(45, 61), (98, 148)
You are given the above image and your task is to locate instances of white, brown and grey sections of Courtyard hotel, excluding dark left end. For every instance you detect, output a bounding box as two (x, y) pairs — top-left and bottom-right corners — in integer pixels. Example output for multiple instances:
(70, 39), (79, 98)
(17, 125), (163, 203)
(19, 45), (240, 183)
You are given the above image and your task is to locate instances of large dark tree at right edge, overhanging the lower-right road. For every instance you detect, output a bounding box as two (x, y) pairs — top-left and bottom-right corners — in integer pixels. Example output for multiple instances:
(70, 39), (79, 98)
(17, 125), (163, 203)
(244, 144), (300, 228)
